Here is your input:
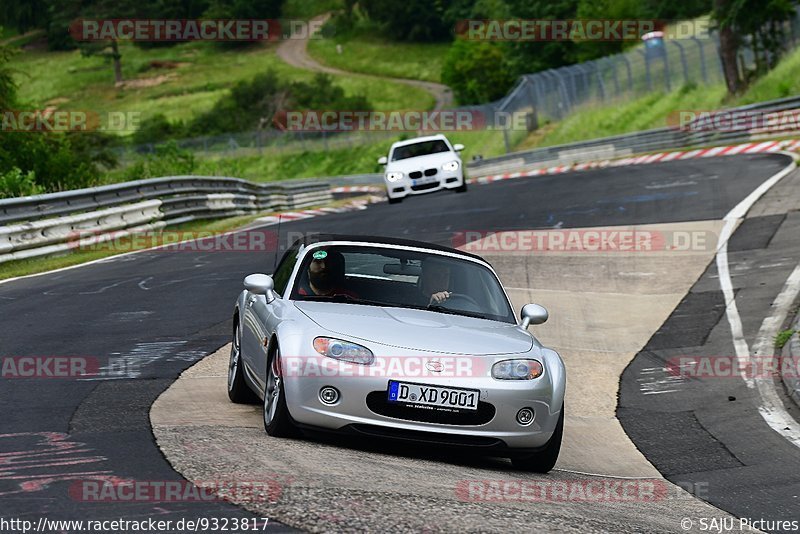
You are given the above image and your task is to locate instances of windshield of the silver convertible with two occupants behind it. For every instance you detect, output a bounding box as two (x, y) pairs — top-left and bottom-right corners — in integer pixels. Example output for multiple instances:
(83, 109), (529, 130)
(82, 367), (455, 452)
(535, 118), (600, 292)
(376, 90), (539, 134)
(290, 245), (515, 323)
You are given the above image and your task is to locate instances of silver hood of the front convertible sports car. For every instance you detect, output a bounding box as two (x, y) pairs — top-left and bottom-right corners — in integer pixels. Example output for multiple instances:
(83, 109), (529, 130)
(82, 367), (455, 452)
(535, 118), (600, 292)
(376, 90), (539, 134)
(294, 302), (533, 355)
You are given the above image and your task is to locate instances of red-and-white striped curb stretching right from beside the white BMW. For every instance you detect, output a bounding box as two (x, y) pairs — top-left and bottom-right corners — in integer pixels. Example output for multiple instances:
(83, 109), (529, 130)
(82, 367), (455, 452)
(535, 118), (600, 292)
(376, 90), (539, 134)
(469, 139), (800, 184)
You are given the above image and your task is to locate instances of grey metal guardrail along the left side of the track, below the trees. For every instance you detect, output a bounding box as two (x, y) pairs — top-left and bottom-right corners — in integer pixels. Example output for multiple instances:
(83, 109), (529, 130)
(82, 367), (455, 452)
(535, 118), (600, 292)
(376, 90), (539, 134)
(0, 176), (332, 263)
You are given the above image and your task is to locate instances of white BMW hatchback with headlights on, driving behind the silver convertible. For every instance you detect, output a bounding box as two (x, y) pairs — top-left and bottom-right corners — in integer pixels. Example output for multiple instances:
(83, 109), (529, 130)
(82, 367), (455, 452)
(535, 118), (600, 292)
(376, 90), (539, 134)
(378, 134), (467, 204)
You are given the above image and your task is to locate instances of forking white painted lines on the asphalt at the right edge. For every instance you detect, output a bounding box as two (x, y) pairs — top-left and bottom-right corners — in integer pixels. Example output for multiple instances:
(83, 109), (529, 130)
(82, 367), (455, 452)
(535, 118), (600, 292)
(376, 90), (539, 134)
(716, 155), (800, 447)
